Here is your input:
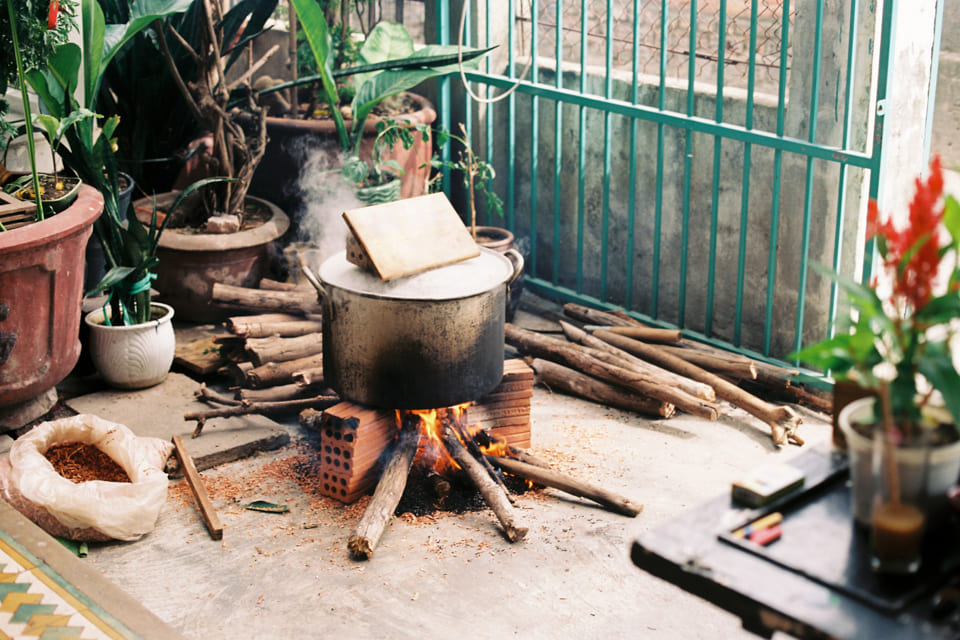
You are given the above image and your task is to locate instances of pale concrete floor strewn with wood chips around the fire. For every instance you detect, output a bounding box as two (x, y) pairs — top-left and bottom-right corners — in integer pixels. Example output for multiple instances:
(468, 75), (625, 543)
(65, 358), (830, 640)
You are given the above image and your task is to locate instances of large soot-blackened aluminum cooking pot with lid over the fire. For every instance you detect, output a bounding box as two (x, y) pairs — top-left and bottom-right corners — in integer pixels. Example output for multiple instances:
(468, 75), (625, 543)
(319, 249), (523, 409)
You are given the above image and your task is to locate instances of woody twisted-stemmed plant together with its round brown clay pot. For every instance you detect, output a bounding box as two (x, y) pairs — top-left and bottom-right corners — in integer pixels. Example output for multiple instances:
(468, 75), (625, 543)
(112, 0), (289, 322)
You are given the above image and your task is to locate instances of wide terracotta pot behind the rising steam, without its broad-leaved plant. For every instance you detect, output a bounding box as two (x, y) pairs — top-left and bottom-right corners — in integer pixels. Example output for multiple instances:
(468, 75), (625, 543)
(250, 93), (437, 212)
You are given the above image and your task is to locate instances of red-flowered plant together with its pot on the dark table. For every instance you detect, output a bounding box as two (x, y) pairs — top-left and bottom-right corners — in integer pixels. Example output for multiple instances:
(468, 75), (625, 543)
(795, 158), (960, 570)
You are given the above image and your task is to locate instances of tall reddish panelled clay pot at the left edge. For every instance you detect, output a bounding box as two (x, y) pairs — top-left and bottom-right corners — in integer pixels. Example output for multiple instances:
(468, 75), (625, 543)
(0, 185), (103, 430)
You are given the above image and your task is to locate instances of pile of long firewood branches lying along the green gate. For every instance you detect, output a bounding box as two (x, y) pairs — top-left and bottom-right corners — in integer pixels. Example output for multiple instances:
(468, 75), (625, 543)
(506, 304), (829, 446)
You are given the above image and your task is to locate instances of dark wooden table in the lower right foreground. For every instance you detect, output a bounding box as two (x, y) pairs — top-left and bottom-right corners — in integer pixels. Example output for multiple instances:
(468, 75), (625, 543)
(631, 446), (960, 639)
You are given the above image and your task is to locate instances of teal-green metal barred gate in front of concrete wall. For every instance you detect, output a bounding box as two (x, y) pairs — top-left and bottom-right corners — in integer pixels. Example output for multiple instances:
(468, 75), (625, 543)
(439, 0), (896, 368)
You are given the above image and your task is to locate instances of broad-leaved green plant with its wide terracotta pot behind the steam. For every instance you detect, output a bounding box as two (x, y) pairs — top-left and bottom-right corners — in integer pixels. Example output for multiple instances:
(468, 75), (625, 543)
(255, 5), (489, 210)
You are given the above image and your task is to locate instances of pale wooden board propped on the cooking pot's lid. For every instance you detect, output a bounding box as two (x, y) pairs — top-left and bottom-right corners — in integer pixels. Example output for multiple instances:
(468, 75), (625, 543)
(343, 193), (480, 280)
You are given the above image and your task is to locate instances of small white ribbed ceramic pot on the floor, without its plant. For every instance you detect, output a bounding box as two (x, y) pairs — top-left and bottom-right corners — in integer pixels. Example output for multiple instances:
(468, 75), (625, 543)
(84, 302), (176, 389)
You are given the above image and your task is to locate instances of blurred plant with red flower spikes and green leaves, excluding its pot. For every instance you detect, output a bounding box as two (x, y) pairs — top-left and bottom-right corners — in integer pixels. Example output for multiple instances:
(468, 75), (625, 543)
(794, 157), (960, 437)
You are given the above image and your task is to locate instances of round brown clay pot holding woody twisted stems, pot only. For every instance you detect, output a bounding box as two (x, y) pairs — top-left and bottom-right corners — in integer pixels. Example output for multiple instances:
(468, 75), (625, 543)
(134, 193), (290, 323)
